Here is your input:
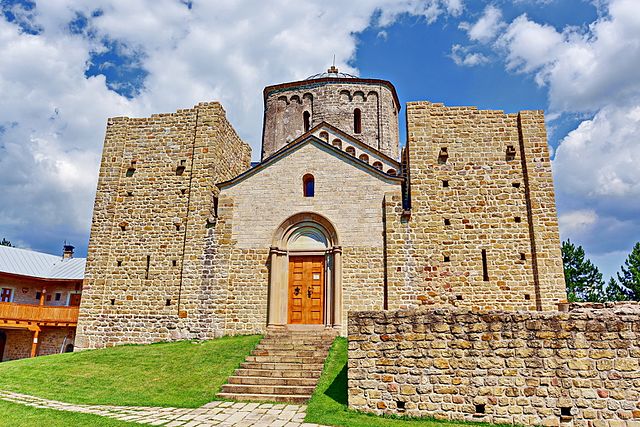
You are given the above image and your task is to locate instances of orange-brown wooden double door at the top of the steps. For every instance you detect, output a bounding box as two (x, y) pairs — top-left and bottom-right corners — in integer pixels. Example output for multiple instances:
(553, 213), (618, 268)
(288, 255), (325, 324)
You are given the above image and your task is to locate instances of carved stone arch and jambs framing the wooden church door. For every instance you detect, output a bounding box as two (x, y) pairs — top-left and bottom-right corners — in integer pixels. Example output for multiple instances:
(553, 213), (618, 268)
(268, 212), (342, 328)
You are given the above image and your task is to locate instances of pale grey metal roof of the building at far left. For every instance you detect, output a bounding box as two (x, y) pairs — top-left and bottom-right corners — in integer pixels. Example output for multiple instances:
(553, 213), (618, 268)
(0, 246), (87, 280)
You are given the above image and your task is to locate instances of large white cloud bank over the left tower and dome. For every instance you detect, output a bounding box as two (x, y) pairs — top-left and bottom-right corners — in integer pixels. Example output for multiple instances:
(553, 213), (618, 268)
(0, 0), (464, 254)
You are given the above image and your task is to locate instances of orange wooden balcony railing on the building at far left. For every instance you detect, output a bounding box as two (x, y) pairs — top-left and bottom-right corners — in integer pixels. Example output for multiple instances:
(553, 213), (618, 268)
(0, 302), (79, 330)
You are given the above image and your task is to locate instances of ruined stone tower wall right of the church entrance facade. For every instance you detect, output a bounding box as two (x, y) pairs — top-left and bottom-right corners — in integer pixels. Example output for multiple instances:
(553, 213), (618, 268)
(385, 102), (566, 310)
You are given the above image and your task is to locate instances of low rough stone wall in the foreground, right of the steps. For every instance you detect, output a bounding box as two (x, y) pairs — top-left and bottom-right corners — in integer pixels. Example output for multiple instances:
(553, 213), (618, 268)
(349, 305), (640, 427)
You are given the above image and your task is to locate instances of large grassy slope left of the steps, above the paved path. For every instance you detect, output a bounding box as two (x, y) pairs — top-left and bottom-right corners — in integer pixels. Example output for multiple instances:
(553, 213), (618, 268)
(0, 335), (260, 411)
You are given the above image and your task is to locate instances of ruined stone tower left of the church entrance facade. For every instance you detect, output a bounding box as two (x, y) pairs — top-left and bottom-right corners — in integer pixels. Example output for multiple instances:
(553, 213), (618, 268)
(77, 102), (250, 349)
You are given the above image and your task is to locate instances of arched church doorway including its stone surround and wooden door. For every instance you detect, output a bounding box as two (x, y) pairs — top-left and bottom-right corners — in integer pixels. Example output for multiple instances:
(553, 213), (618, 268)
(268, 212), (342, 328)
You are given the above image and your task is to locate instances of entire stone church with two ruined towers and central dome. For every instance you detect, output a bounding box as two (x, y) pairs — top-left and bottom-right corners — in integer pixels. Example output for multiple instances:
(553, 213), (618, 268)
(76, 67), (566, 349)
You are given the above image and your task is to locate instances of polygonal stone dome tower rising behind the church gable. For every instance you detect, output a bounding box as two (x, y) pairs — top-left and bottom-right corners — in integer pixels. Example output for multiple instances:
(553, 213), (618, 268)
(262, 66), (400, 159)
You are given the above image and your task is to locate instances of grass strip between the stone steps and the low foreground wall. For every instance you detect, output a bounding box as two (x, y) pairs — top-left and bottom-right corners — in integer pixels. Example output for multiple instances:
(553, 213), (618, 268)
(305, 338), (496, 427)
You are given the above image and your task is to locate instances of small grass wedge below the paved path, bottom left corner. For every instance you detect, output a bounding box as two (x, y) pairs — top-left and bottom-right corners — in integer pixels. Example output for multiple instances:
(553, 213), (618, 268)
(0, 400), (139, 427)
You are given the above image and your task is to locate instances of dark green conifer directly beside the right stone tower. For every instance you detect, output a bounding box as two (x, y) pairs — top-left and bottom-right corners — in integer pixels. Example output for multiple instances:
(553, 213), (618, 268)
(562, 240), (605, 302)
